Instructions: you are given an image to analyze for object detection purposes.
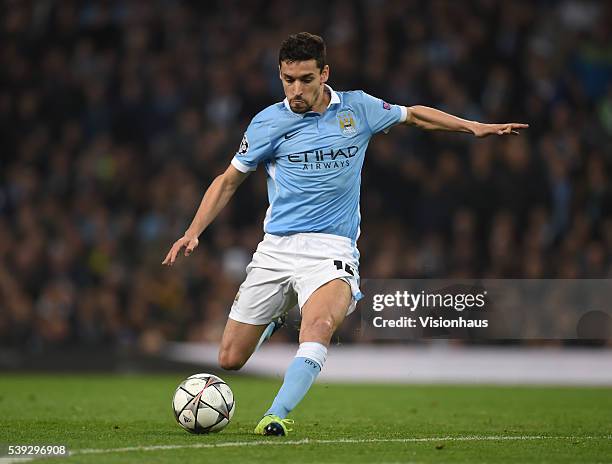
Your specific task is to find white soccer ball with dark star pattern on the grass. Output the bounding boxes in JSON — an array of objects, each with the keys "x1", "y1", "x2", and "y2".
[{"x1": 172, "y1": 374, "x2": 236, "y2": 433}]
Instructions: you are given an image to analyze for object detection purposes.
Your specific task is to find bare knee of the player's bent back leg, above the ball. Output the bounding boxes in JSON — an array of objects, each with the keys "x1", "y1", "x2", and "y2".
[{"x1": 219, "y1": 319, "x2": 267, "y2": 370}]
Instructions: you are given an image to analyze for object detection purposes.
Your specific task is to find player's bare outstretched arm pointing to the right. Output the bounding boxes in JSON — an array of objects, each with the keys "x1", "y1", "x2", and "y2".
[{"x1": 404, "y1": 105, "x2": 529, "y2": 137}]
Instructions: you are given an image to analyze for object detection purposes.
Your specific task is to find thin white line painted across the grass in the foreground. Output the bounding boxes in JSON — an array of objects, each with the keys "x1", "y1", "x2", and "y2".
[{"x1": 70, "y1": 435, "x2": 612, "y2": 456}]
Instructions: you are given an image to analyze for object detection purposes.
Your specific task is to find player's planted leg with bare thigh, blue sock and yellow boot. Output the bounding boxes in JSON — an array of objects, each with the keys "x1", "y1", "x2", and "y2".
[{"x1": 255, "y1": 279, "x2": 352, "y2": 435}]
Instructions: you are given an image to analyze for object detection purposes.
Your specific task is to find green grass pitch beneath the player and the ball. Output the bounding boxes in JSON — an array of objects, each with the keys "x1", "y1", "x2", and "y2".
[{"x1": 0, "y1": 374, "x2": 612, "y2": 463}]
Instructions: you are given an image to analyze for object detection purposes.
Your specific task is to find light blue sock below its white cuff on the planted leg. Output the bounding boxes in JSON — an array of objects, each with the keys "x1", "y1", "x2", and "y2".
[{"x1": 265, "y1": 358, "x2": 321, "y2": 419}]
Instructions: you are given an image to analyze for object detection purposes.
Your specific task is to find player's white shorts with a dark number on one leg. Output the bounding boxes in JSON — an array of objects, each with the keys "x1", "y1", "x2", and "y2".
[{"x1": 229, "y1": 233, "x2": 362, "y2": 325}]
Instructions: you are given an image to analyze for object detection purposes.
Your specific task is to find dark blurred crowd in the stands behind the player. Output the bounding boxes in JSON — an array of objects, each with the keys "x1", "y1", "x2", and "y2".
[{"x1": 0, "y1": 0, "x2": 612, "y2": 352}]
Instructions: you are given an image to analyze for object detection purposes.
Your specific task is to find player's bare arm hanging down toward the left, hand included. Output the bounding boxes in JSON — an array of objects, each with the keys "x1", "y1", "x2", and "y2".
[{"x1": 162, "y1": 164, "x2": 250, "y2": 266}]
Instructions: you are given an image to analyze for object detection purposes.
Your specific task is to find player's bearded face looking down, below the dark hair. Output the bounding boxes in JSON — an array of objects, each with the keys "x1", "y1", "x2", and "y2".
[{"x1": 279, "y1": 60, "x2": 329, "y2": 113}]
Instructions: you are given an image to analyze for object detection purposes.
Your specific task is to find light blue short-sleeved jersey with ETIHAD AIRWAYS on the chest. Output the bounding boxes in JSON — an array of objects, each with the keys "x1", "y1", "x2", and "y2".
[{"x1": 232, "y1": 87, "x2": 406, "y2": 242}]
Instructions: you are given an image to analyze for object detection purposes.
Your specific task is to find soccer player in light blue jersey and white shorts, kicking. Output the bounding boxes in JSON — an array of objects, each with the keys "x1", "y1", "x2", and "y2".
[{"x1": 163, "y1": 32, "x2": 528, "y2": 435}]
